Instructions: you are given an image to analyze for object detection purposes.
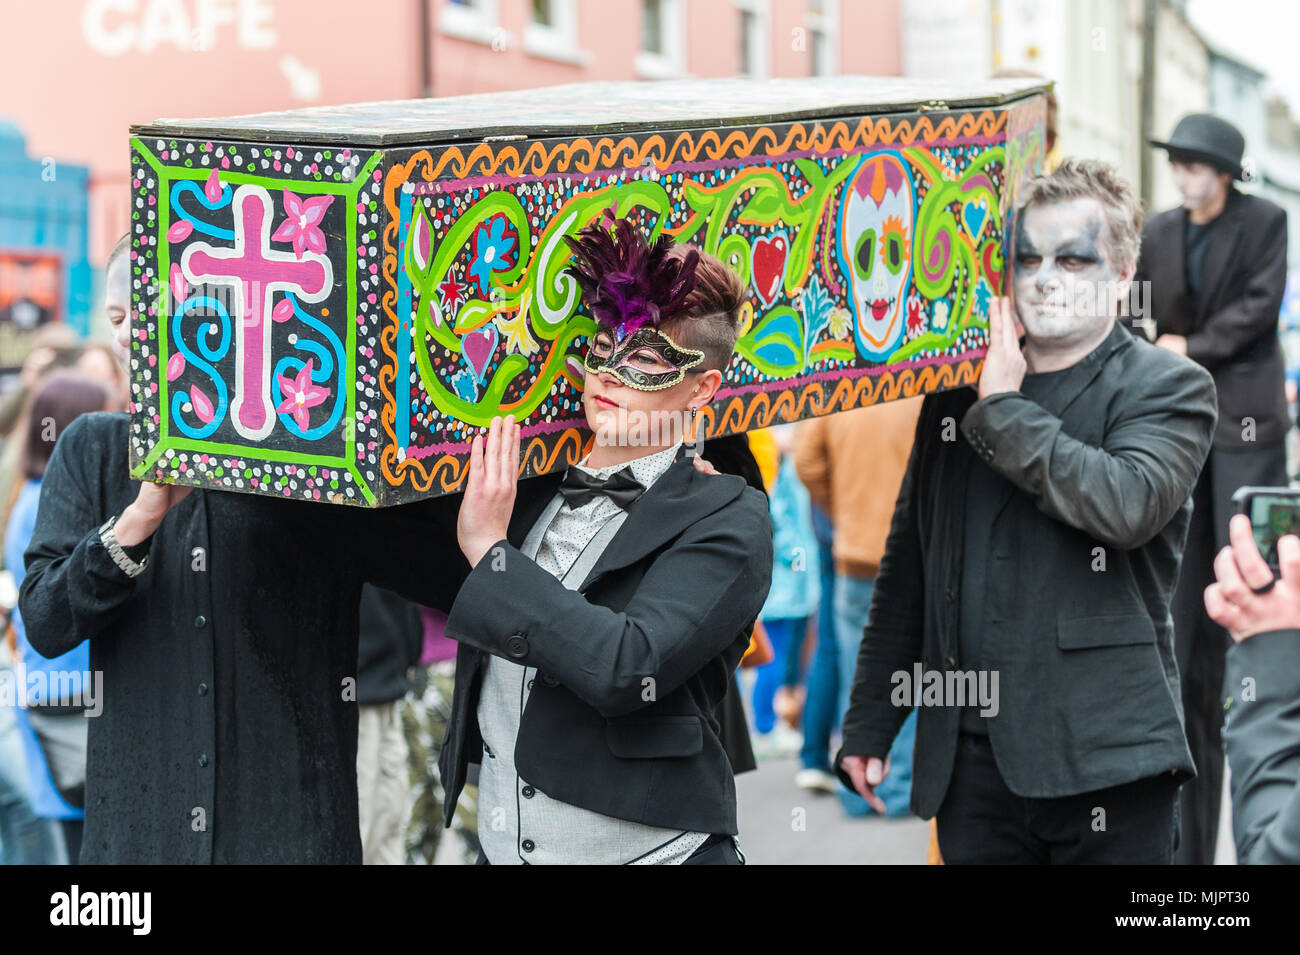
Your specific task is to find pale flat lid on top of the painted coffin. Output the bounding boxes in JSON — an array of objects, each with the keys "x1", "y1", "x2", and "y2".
[{"x1": 131, "y1": 75, "x2": 1052, "y2": 147}]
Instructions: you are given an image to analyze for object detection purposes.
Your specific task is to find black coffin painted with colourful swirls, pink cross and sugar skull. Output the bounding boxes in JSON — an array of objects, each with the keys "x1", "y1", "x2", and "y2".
[{"x1": 130, "y1": 77, "x2": 1045, "y2": 507}]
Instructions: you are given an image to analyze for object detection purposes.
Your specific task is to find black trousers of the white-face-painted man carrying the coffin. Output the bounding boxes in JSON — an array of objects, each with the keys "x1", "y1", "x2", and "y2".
[{"x1": 936, "y1": 734, "x2": 1178, "y2": 865}]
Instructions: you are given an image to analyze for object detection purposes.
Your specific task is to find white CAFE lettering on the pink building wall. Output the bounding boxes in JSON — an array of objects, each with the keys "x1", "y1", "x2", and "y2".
[{"x1": 82, "y1": 0, "x2": 280, "y2": 56}]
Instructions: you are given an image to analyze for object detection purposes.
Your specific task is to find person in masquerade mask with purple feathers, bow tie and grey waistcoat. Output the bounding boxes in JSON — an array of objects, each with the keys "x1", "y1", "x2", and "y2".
[{"x1": 439, "y1": 213, "x2": 772, "y2": 864}]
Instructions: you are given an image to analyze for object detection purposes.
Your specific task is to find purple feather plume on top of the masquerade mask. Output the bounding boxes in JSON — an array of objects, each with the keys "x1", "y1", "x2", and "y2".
[{"x1": 564, "y1": 212, "x2": 699, "y2": 334}]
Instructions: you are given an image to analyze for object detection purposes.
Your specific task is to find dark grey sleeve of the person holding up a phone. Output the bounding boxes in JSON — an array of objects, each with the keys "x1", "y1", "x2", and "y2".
[{"x1": 1223, "y1": 630, "x2": 1300, "y2": 865}]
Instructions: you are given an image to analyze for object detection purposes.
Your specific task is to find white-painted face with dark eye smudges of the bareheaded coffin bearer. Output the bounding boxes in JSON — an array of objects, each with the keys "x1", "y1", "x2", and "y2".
[{"x1": 1013, "y1": 199, "x2": 1131, "y2": 350}]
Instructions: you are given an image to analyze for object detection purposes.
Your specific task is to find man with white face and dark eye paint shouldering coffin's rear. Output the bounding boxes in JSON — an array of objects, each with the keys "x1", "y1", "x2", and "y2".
[{"x1": 836, "y1": 160, "x2": 1216, "y2": 863}]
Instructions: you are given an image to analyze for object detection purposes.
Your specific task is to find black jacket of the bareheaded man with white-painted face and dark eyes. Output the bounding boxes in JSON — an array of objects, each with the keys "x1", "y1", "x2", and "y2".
[{"x1": 836, "y1": 324, "x2": 1214, "y2": 817}]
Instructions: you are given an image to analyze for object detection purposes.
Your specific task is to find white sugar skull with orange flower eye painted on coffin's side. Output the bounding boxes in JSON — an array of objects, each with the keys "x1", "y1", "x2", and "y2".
[{"x1": 840, "y1": 153, "x2": 914, "y2": 359}]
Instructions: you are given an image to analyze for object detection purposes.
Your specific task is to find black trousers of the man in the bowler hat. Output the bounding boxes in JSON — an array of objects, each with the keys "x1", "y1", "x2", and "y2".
[{"x1": 1171, "y1": 444, "x2": 1287, "y2": 865}]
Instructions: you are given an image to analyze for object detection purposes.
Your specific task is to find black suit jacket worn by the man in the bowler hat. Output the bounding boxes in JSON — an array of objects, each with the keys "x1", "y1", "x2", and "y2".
[{"x1": 1135, "y1": 190, "x2": 1291, "y2": 451}]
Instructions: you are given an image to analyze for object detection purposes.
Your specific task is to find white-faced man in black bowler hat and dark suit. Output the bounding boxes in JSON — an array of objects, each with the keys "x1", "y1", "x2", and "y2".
[{"x1": 1134, "y1": 113, "x2": 1291, "y2": 864}]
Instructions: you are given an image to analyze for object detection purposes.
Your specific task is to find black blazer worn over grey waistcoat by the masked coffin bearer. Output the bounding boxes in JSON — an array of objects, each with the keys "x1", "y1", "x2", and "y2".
[{"x1": 438, "y1": 456, "x2": 772, "y2": 834}]
